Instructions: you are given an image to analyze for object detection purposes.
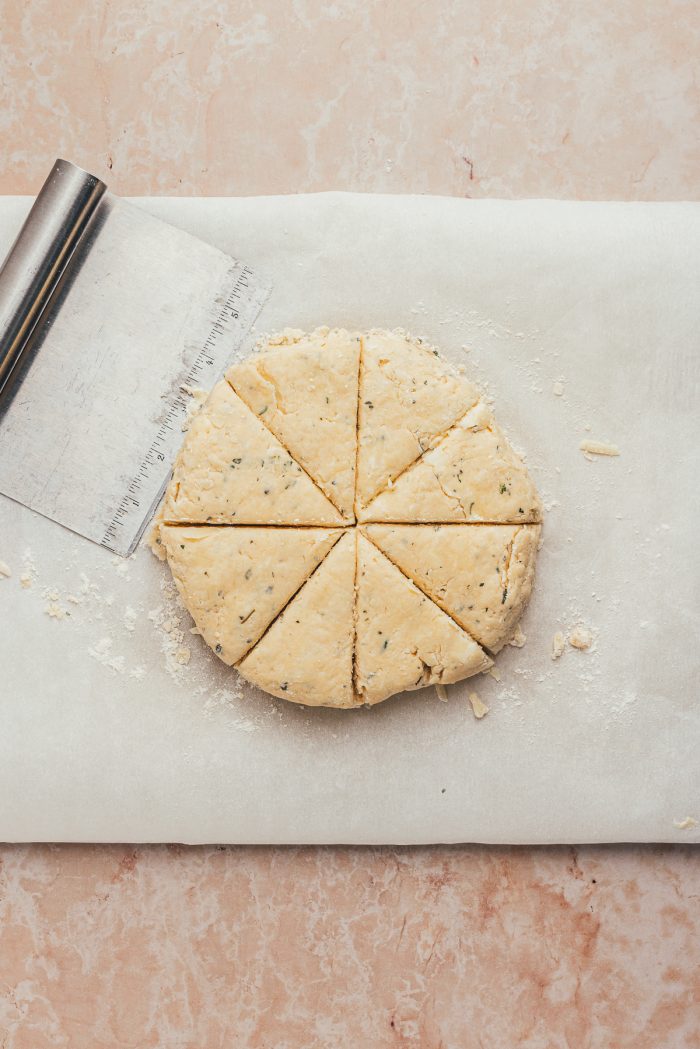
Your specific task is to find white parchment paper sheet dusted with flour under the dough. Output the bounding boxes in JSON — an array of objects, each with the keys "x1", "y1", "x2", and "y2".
[{"x1": 0, "y1": 194, "x2": 700, "y2": 842}]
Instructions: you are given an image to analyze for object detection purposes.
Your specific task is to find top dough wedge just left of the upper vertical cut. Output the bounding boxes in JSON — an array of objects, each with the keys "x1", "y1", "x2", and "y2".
[{"x1": 226, "y1": 328, "x2": 360, "y2": 521}]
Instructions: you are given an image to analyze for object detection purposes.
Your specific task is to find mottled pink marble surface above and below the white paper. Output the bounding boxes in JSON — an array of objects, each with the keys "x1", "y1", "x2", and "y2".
[{"x1": 0, "y1": 0, "x2": 700, "y2": 1049}]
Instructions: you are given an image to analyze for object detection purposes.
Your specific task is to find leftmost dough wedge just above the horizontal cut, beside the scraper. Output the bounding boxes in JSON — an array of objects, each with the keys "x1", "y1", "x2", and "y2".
[{"x1": 163, "y1": 382, "x2": 343, "y2": 525}]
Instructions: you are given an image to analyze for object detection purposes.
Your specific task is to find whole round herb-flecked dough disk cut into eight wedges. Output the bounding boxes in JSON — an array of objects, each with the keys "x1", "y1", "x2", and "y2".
[{"x1": 157, "y1": 328, "x2": 542, "y2": 708}]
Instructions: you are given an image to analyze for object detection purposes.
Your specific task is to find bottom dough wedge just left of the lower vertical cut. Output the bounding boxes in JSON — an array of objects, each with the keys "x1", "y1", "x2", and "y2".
[{"x1": 238, "y1": 534, "x2": 356, "y2": 707}]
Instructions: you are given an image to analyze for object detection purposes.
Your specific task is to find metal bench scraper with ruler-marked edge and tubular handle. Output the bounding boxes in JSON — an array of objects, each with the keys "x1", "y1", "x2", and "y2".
[{"x1": 0, "y1": 160, "x2": 270, "y2": 556}]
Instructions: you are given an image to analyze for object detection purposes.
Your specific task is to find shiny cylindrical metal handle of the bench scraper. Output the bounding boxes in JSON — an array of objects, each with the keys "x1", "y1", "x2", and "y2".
[{"x1": 0, "y1": 160, "x2": 107, "y2": 398}]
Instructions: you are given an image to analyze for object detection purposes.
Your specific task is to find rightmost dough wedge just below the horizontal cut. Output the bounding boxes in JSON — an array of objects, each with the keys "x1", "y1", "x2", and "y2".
[{"x1": 365, "y1": 525, "x2": 540, "y2": 652}]
